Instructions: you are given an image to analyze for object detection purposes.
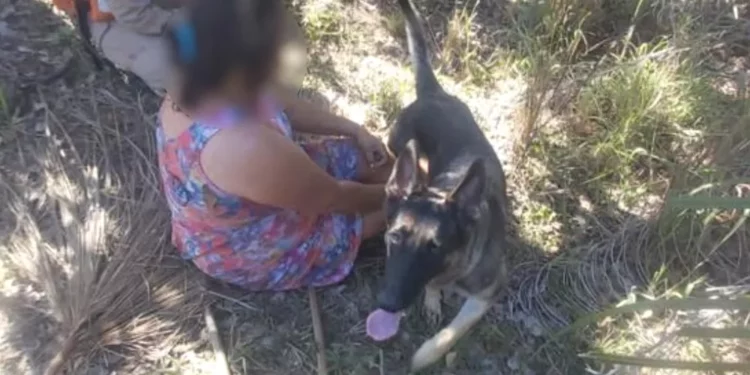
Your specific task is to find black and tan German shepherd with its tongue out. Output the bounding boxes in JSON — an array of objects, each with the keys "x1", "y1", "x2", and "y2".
[{"x1": 377, "y1": 0, "x2": 507, "y2": 371}]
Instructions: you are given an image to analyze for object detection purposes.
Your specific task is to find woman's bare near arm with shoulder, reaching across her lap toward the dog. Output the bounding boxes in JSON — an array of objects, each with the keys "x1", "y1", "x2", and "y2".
[{"x1": 201, "y1": 126, "x2": 385, "y2": 215}]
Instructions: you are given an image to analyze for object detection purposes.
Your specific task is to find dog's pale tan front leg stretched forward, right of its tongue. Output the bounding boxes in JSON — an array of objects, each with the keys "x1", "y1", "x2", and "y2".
[{"x1": 411, "y1": 297, "x2": 491, "y2": 372}]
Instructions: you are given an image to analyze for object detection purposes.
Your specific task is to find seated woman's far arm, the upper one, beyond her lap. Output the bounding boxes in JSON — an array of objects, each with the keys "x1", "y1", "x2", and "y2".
[{"x1": 278, "y1": 90, "x2": 367, "y2": 138}]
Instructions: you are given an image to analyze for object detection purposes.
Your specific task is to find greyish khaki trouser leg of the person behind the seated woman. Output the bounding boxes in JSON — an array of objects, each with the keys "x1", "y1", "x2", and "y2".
[{"x1": 91, "y1": 21, "x2": 171, "y2": 96}]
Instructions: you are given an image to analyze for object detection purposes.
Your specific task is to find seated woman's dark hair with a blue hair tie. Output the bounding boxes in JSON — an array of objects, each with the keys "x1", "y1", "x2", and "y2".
[{"x1": 166, "y1": 0, "x2": 284, "y2": 108}]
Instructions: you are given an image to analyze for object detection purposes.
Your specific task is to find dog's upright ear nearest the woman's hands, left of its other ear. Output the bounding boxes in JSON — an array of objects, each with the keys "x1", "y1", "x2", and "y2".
[{"x1": 385, "y1": 138, "x2": 424, "y2": 197}]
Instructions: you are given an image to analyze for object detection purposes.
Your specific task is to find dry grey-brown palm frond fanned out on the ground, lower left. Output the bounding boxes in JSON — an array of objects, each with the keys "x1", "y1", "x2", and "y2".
[{"x1": 4, "y1": 150, "x2": 202, "y2": 374}]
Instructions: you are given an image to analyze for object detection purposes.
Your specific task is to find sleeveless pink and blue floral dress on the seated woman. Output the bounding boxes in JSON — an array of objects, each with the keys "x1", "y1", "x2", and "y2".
[{"x1": 157, "y1": 98, "x2": 362, "y2": 291}]
